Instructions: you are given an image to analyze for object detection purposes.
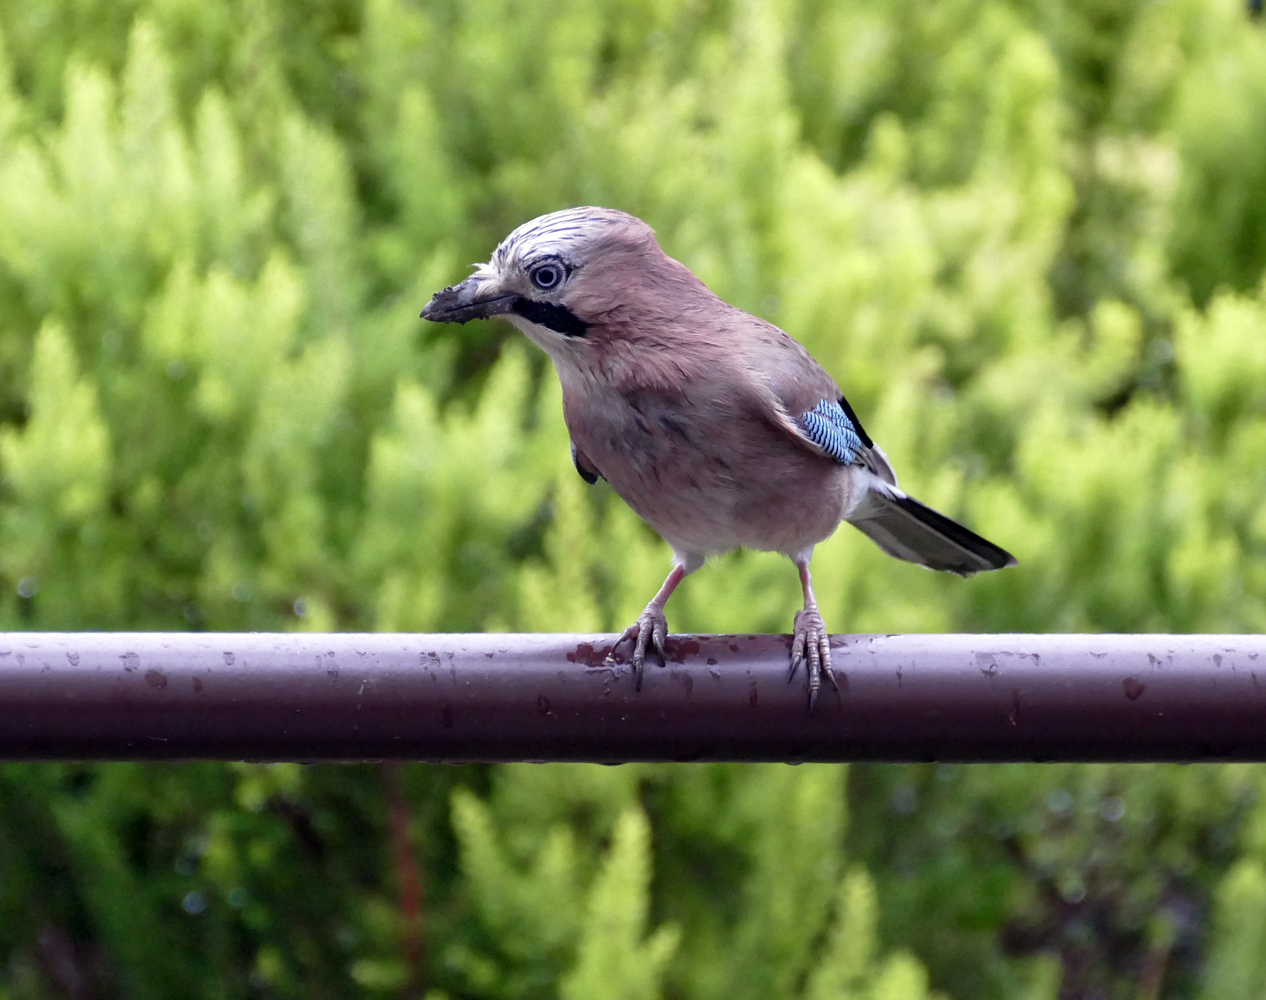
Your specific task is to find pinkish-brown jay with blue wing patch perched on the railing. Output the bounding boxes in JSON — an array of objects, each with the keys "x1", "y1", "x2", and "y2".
[{"x1": 422, "y1": 206, "x2": 1017, "y2": 713}]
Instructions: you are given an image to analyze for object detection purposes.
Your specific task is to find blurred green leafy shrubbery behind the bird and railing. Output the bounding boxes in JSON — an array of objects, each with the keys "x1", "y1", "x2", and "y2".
[{"x1": 0, "y1": 0, "x2": 1266, "y2": 1000}]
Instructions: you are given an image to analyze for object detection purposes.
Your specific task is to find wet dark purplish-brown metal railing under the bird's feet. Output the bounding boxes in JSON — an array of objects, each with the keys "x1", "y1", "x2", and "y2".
[{"x1": 0, "y1": 633, "x2": 1266, "y2": 762}]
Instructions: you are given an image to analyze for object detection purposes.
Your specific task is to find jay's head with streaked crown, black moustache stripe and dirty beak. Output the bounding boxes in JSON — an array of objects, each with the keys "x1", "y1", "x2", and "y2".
[{"x1": 422, "y1": 208, "x2": 694, "y2": 356}]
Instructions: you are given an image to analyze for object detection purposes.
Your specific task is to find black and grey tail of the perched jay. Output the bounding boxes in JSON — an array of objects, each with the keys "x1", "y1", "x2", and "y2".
[{"x1": 848, "y1": 482, "x2": 1015, "y2": 576}]
